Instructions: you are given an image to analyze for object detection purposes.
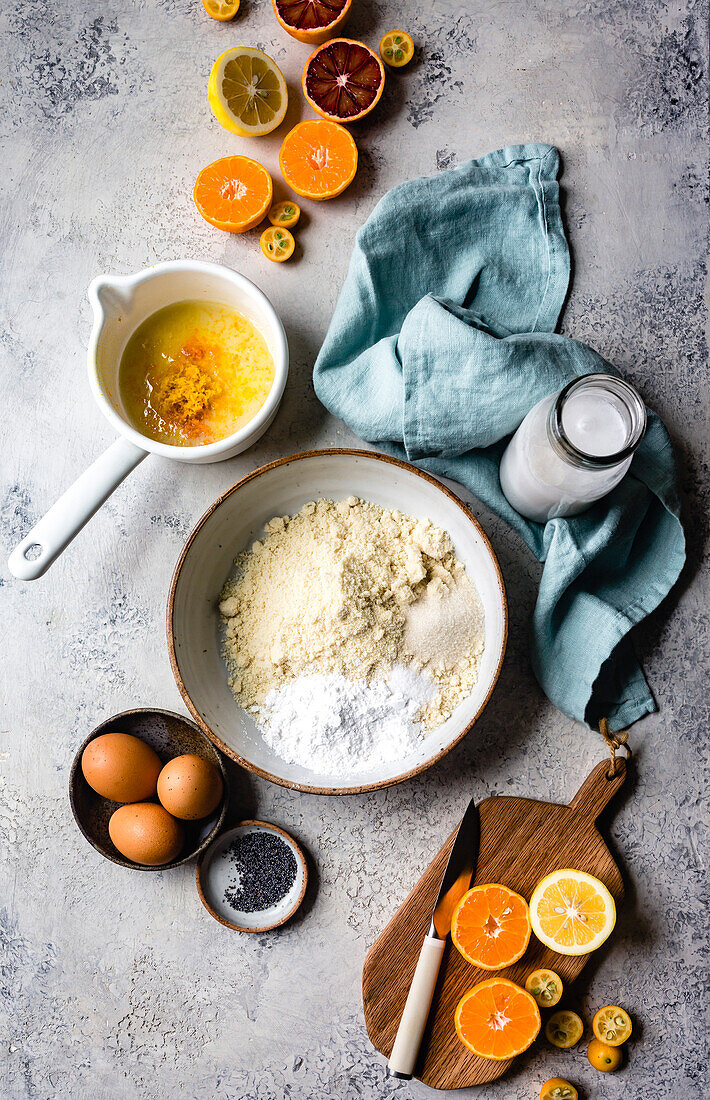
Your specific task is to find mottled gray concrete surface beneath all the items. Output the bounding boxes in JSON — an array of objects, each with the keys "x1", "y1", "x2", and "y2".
[{"x1": 0, "y1": 0, "x2": 709, "y2": 1100}]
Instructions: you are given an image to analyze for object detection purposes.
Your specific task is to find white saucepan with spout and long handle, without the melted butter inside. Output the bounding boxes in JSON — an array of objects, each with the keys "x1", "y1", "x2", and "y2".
[{"x1": 8, "y1": 260, "x2": 288, "y2": 581}]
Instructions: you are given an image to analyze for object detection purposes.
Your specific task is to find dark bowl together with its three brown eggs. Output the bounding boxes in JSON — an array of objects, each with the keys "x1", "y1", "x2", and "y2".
[{"x1": 69, "y1": 708, "x2": 227, "y2": 871}]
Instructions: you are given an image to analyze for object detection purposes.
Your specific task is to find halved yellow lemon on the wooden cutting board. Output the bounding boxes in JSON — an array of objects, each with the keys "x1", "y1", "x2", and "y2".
[{"x1": 531, "y1": 868, "x2": 616, "y2": 955}]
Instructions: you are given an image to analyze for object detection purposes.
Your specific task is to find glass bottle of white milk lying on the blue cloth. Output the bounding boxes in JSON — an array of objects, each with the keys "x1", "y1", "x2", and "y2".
[{"x1": 500, "y1": 374, "x2": 646, "y2": 524}]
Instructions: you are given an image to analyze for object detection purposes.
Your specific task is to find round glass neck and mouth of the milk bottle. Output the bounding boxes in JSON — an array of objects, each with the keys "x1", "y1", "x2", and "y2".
[{"x1": 547, "y1": 374, "x2": 646, "y2": 470}]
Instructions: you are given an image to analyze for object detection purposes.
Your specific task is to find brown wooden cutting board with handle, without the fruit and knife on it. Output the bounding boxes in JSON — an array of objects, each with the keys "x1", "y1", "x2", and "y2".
[{"x1": 362, "y1": 757, "x2": 626, "y2": 1089}]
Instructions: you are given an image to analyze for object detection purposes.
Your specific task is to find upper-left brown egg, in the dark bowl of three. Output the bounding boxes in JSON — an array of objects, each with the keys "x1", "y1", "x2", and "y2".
[{"x1": 81, "y1": 734, "x2": 163, "y2": 802}]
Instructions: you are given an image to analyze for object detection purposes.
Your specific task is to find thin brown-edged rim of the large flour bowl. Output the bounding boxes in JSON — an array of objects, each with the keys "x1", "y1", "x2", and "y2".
[{"x1": 165, "y1": 447, "x2": 509, "y2": 794}]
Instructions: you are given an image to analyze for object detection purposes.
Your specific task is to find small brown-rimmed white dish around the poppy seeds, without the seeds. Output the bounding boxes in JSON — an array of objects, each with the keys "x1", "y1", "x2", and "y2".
[{"x1": 195, "y1": 822, "x2": 308, "y2": 932}]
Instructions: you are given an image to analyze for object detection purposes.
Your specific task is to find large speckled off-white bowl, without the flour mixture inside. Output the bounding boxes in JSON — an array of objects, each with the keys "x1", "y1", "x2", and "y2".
[{"x1": 167, "y1": 450, "x2": 507, "y2": 794}]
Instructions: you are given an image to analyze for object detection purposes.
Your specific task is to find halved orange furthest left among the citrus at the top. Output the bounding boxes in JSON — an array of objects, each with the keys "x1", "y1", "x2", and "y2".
[{"x1": 193, "y1": 156, "x2": 274, "y2": 233}]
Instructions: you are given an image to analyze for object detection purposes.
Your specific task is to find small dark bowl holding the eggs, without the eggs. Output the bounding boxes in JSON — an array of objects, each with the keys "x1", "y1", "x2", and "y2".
[{"x1": 69, "y1": 707, "x2": 228, "y2": 871}]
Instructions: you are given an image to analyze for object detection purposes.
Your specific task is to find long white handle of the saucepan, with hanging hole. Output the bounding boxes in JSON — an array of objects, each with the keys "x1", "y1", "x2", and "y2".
[{"x1": 8, "y1": 439, "x2": 148, "y2": 581}]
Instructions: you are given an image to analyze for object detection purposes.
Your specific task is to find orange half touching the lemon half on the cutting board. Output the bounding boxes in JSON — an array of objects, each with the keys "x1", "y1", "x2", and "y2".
[{"x1": 451, "y1": 882, "x2": 531, "y2": 970}]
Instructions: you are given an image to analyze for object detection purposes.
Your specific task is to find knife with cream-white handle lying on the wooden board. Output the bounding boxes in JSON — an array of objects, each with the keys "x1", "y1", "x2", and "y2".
[{"x1": 387, "y1": 799, "x2": 480, "y2": 1081}]
